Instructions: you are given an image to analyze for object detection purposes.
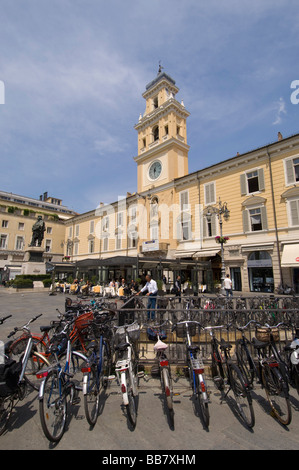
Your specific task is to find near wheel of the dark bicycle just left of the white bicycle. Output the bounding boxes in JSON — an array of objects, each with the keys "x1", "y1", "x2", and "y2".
[{"x1": 83, "y1": 364, "x2": 100, "y2": 426}]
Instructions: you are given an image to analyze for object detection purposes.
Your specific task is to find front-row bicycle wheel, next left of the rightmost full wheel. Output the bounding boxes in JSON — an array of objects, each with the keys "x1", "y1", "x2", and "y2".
[{"x1": 229, "y1": 364, "x2": 255, "y2": 428}]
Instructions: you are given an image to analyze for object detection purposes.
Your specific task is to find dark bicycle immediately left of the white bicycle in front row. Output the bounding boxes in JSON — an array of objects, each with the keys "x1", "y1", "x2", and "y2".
[{"x1": 82, "y1": 314, "x2": 114, "y2": 426}]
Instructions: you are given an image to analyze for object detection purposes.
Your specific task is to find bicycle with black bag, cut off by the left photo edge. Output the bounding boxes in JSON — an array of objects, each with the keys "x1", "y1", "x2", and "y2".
[{"x1": 0, "y1": 315, "x2": 49, "y2": 436}]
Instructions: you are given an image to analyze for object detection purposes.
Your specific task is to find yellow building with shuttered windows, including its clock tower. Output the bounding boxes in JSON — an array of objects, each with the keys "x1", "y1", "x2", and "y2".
[{"x1": 64, "y1": 71, "x2": 299, "y2": 292}]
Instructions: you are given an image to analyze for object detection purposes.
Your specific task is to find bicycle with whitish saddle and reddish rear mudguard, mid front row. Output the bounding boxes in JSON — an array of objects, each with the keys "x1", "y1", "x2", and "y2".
[{"x1": 144, "y1": 320, "x2": 174, "y2": 428}]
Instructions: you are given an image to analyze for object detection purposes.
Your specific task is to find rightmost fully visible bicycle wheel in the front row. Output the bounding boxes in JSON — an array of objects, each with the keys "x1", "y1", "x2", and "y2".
[{"x1": 262, "y1": 364, "x2": 292, "y2": 426}]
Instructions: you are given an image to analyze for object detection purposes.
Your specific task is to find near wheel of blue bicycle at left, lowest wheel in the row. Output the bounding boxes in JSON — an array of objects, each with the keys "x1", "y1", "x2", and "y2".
[{"x1": 39, "y1": 371, "x2": 67, "y2": 442}]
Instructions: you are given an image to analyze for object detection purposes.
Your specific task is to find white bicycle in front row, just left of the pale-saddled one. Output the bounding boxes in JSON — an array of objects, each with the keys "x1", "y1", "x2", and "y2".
[{"x1": 114, "y1": 322, "x2": 140, "y2": 428}]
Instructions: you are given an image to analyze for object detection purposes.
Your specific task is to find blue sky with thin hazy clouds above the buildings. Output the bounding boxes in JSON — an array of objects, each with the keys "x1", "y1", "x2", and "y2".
[{"x1": 0, "y1": 0, "x2": 299, "y2": 212}]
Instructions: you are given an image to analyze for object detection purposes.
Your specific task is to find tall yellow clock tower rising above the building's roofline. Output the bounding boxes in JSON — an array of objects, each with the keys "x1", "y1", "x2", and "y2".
[{"x1": 134, "y1": 67, "x2": 190, "y2": 193}]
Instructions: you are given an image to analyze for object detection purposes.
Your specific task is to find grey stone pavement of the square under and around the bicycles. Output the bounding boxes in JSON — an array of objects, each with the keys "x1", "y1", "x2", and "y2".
[{"x1": 0, "y1": 290, "x2": 299, "y2": 454}]
